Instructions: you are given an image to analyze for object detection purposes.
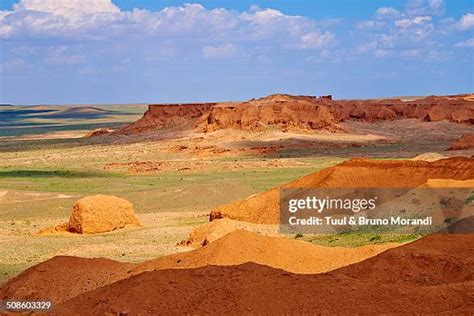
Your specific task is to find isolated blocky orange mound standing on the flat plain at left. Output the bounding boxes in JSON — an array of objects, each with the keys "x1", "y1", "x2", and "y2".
[{"x1": 38, "y1": 194, "x2": 140, "y2": 235}]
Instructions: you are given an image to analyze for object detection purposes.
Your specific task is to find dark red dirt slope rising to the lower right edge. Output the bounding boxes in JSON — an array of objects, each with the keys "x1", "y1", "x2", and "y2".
[{"x1": 338, "y1": 232, "x2": 474, "y2": 286}]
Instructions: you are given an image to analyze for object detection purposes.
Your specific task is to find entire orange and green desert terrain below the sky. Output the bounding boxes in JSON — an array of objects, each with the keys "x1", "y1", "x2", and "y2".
[{"x1": 0, "y1": 94, "x2": 474, "y2": 315}]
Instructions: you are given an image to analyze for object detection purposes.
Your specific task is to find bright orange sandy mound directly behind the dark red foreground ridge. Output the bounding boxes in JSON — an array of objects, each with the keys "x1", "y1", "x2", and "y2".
[{"x1": 133, "y1": 230, "x2": 399, "y2": 273}]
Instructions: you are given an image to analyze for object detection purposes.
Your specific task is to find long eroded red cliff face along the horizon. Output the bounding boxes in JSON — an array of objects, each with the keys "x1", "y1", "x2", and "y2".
[{"x1": 119, "y1": 94, "x2": 474, "y2": 134}]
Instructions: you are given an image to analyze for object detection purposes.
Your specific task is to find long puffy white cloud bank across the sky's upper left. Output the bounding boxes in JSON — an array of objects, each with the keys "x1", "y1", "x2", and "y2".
[{"x1": 0, "y1": 0, "x2": 334, "y2": 48}]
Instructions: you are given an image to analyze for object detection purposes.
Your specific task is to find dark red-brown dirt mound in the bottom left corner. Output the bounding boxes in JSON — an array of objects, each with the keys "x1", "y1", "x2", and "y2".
[{"x1": 0, "y1": 257, "x2": 134, "y2": 304}]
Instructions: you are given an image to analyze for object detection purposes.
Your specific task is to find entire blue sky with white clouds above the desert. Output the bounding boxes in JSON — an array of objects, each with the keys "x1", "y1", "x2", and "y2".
[{"x1": 0, "y1": 0, "x2": 474, "y2": 104}]
